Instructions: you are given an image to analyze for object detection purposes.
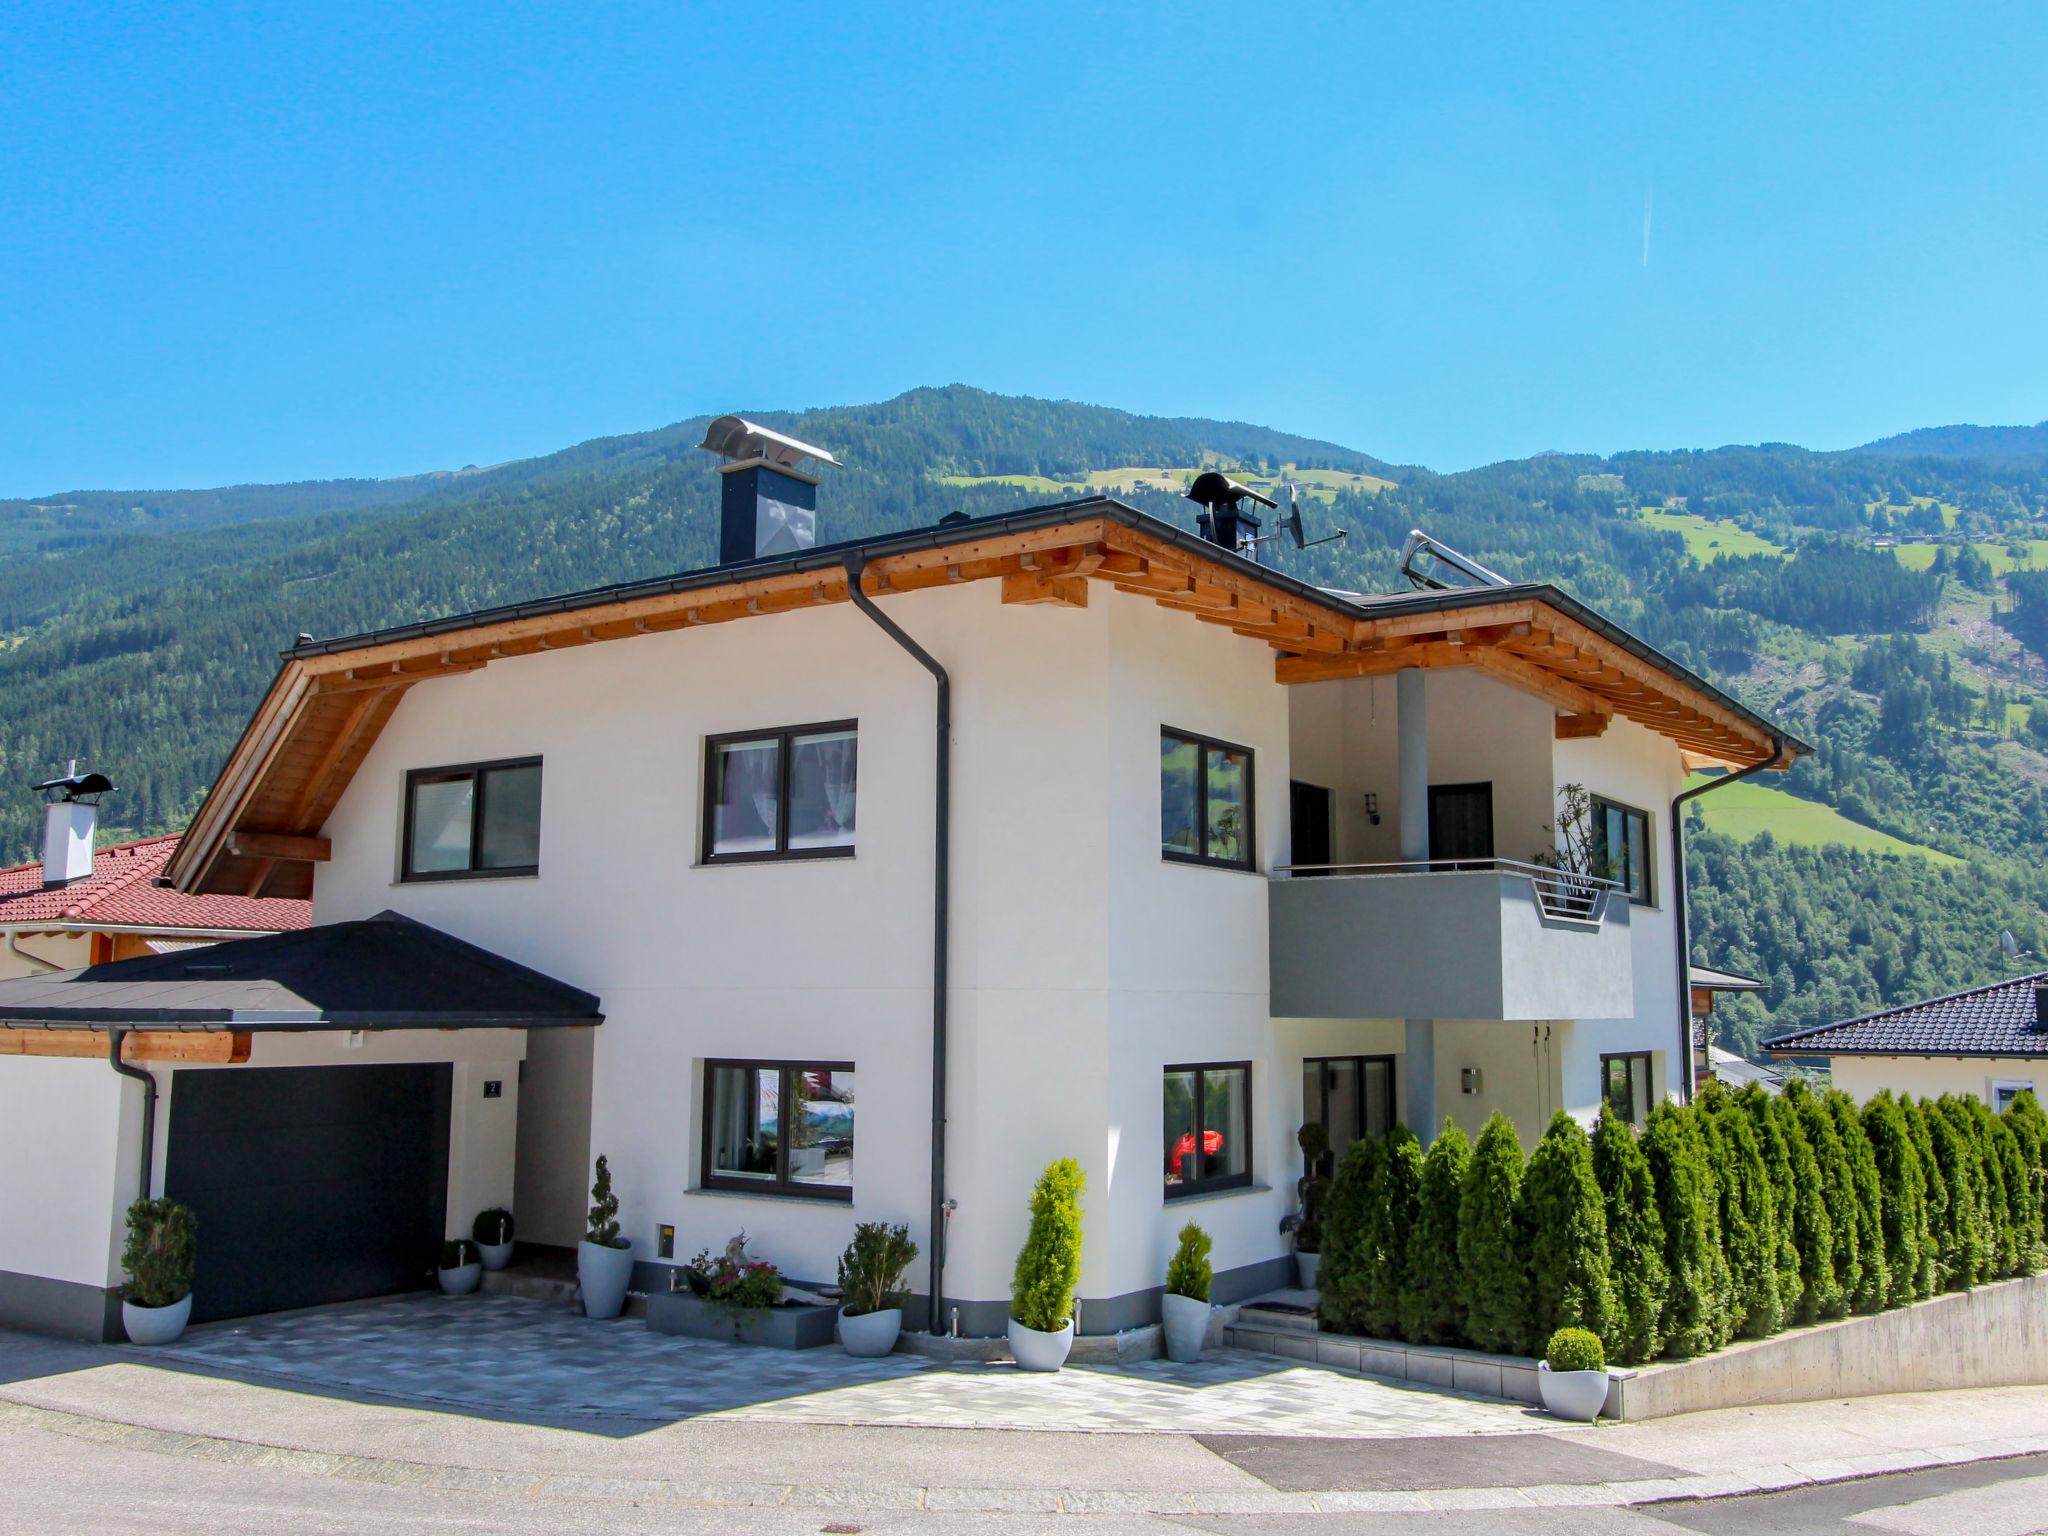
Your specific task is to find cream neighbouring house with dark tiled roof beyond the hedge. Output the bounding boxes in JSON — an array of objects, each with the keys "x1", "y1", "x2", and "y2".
[{"x1": 1763, "y1": 971, "x2": 2048, "y2": 1110}]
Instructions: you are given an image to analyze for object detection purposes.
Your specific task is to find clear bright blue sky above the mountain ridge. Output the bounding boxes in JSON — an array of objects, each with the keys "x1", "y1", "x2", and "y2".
[{"x1": 0, "y1": 2, "x2": 2048, "y2": 494}]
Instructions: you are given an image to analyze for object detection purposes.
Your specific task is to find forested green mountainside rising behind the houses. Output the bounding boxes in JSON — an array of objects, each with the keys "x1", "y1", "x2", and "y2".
[{"x1": 0, "y1": 387, "x2": 2048, "y2": 1049}]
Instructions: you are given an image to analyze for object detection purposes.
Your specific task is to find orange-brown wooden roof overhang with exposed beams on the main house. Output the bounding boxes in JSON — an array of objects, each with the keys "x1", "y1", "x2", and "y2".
[{"x1": 168, "y1": 498, "x2": 1806, "y2": 897}]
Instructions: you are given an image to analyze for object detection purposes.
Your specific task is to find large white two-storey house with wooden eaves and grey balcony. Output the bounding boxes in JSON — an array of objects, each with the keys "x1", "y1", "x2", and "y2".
[{"x1": 0, "y1": 420, "x2": 1806, "y2": 1333}]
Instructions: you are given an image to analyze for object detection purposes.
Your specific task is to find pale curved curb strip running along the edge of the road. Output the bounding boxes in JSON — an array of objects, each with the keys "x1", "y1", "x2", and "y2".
[{"x1": 0, "y1": 1399, "x2": 2048, "y2": 1516}]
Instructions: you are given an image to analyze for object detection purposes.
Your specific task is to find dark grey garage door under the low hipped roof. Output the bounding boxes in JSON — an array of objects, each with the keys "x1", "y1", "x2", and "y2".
[{"x1": 164, "y1": 1065, "x2": 451, "y2": 1323}]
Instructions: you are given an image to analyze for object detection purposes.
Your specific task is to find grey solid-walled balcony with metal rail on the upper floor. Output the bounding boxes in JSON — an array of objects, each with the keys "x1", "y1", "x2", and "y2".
[{"x1": 1268, "y1": 858, "x2": 1636, "y2": 1020}]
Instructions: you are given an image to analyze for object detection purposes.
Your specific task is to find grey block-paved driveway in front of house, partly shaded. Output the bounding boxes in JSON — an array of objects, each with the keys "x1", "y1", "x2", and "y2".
[{"x1": 133, "y1": 1294, "x2": 1550, "y2": 1438}]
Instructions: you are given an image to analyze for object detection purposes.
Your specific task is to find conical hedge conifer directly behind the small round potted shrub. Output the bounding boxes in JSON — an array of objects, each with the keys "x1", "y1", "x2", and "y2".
[{"x1": 1522, "y1": 1110, "x2": 1614, "y2": 1339}]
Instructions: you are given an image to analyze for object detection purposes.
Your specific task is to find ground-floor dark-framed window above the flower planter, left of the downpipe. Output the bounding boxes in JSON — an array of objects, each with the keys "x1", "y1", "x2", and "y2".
[{"x1": 705, "y1": 1061, "x2": 854, "y2": 1200}]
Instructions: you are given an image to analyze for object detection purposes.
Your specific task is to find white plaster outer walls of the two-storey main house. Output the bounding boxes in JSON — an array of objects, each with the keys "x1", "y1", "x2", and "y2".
[{"x1": 313, "y1": 582, "x2": 1683, "y2": 1331}]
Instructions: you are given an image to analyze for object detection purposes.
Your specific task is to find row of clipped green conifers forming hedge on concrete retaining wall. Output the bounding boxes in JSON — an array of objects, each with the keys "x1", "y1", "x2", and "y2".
[{"x1": 1321, "y1": 1081, "x2": 2048, "y2": 1364}]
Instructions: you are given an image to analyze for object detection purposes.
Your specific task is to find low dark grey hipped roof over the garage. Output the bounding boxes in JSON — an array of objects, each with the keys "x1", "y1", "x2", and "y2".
[{"x1": 0, "y1": 911, "x2": 604, "y2": 1030}]
